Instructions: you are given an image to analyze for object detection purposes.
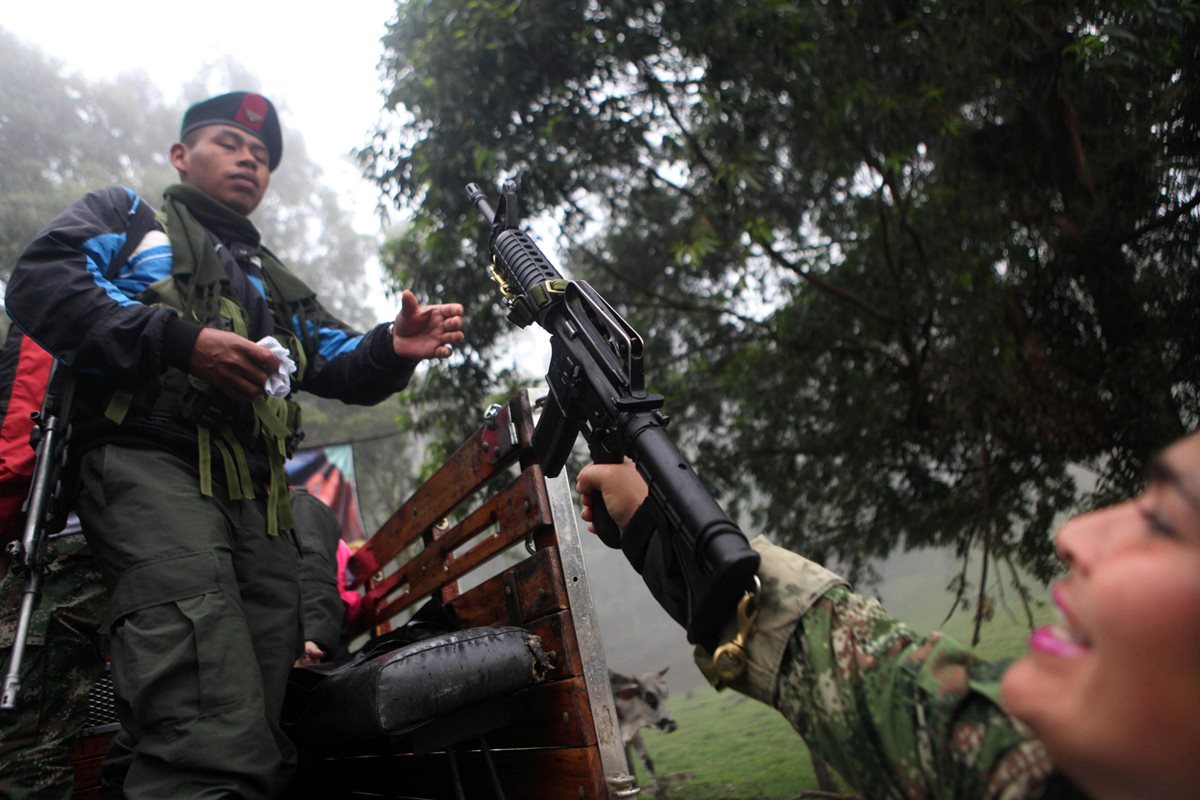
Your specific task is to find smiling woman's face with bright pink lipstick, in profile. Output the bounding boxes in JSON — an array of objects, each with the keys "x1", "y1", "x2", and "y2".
[{"x1": 1002, "y1": 435, "x2": 1200, "y2": 798}]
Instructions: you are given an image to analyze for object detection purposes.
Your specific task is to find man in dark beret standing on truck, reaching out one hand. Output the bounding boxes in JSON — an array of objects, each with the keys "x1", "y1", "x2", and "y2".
[{"x1": 6, "y1": 91, "x2": 462, "y2": 799}]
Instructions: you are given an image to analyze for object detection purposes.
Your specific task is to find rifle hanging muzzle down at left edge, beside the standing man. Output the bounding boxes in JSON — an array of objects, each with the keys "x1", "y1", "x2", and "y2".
[{"x1": 0, "y1": 361, "x2": 74, "y2": 711}]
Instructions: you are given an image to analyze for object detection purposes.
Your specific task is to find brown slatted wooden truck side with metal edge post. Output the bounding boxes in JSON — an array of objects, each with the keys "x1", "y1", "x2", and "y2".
[{"x1": 69, "y1": 392, "x2": 638, "y2": 800}]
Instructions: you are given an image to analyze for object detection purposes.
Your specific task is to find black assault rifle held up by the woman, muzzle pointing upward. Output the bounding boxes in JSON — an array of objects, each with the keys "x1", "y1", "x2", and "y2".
[{"x1": 467, "y1": 184, "x2": 758, "y2": 651}]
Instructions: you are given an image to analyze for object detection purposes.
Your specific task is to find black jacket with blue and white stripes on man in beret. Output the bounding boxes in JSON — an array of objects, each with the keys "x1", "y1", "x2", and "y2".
[{"x1": 5, "y1": 187, "x2": 416, "y2": 472}]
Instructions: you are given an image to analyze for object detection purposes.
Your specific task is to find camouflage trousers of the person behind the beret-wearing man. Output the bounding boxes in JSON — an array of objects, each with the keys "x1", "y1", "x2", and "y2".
[{"x1": 0, "y1": 535, "x2": 108, "y2": 800}]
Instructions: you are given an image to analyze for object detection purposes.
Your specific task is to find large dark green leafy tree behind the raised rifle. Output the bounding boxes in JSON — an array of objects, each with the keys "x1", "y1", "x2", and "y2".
[{"x1": 364, "y1": 0, "x2": 1200, "y2": 633}]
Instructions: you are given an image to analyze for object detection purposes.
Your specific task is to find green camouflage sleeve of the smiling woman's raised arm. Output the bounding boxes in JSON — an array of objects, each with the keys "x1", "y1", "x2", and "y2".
[{"x1": 697, "y1": 540, "x2": 1051, "y2": 800}]
